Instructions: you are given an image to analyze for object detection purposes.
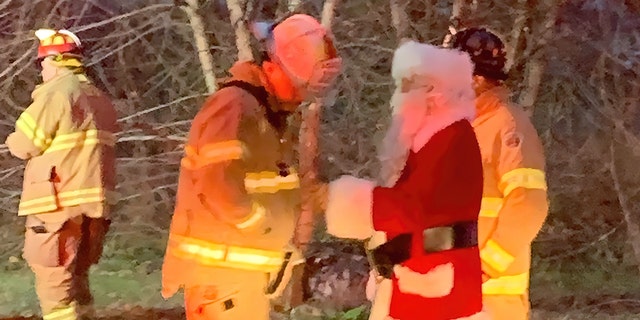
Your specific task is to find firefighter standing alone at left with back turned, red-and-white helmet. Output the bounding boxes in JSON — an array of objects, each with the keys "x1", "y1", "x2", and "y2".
[{"x1": 6, "y1": 29, "x2": 117, "y2": 320}]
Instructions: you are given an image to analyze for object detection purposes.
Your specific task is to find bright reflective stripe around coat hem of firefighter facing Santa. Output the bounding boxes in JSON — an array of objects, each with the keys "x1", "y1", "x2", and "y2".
[{"x1": 169, "y1": 234, "x2": 284, "y2": 272}]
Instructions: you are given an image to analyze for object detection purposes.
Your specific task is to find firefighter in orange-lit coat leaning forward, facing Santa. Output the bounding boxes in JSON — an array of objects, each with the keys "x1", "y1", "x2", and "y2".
[{"x1": 162, "y1": 14, "x2": 341, "y2": 320}]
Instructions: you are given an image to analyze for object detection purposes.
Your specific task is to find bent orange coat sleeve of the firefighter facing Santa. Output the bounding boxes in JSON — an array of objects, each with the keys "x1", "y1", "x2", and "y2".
[{"x1": 181, "y1": 97, "x2": 266, "y2": 231}]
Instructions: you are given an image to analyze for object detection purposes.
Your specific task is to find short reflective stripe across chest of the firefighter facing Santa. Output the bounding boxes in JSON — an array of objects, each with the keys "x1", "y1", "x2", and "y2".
[{"x1": 244, "y1": 171, "x2": 300, "y2": 193}]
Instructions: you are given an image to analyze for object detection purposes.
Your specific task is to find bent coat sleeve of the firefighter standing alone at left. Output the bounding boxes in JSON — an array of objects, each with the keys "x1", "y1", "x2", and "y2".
[{"x1": 5, "y1": 92, "x2": 67, "y2": 160}]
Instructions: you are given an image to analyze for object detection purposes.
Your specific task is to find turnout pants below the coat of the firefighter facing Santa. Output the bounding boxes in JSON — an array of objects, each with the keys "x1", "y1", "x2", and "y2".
[{"x1": 184, "y1": 268, "x2": 270, "y2": 320}]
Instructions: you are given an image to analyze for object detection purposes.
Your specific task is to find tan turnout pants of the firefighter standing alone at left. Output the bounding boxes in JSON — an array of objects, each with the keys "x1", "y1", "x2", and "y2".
[{"x1": 23, "y1": 215, "x2": 110, "y2": 320}]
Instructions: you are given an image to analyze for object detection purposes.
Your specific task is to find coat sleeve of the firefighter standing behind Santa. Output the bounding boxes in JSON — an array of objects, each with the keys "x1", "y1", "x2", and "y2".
[{"x1": 480, "y1": 128, "x2": 548, "y2": 277}]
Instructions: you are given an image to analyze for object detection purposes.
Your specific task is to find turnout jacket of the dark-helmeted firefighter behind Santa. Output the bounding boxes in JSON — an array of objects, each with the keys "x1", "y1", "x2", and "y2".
[{"x1": 473, "y1": 87, "x2": 548, "y2": 295}]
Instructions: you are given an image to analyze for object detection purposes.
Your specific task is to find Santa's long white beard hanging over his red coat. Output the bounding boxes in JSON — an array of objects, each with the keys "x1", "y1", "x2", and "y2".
[{"x1": 378, "y1": 90, "x2": 429, "y2": 187}]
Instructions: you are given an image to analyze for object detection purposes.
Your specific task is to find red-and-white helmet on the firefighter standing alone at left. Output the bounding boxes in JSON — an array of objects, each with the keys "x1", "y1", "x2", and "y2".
[{"x1": 36, "y1": 29, "x2": 82, "y2": 59}]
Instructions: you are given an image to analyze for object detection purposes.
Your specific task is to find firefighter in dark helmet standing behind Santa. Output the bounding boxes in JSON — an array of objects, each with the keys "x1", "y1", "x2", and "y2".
[{"x1": 451, "y1": 28, "x2": 548, "y2": 320}]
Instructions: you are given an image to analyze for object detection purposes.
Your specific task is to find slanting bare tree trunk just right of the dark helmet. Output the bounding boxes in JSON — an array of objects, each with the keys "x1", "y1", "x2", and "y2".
[{"x1": 518, "y1": 0, "x2": 564, "y2": 116}]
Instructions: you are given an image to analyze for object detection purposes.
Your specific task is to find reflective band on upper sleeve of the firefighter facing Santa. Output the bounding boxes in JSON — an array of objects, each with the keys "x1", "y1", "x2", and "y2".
[{"x1": 180, "y1": 140, "x2": 243, "y2": 170}]
